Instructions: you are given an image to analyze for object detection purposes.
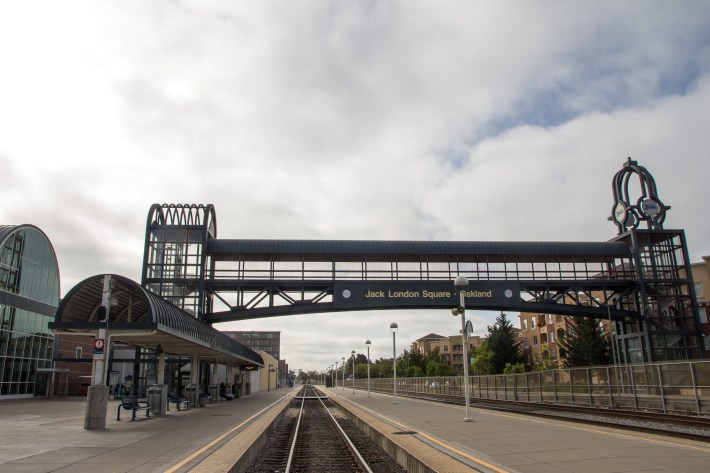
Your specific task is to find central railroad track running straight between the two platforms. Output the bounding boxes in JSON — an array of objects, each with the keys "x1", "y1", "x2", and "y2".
[{"x1": 247, "y1": 386, "x2": 404, "y2": 473}]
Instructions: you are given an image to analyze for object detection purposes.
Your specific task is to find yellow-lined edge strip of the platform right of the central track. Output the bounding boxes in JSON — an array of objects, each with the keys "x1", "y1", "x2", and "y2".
[{"x1": 332, "y1": 390, "x2": 508, "y2": 473}]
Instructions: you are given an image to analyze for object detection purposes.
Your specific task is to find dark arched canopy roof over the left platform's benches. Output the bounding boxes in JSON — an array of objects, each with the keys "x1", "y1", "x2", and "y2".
[{"x1": 49, "y1": 275, "x2": 264, "y2": 367}]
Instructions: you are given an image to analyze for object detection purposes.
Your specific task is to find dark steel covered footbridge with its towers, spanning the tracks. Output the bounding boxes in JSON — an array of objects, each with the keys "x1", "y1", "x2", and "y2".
[{"x1": 142, "y1": 204, "x2": 702, "y2": 361}]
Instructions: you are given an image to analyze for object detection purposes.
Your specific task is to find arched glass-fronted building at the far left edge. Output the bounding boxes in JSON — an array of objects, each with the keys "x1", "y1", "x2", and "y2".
[{"x1": 0, "y1": 225, "x2": 59, "y2": 398}]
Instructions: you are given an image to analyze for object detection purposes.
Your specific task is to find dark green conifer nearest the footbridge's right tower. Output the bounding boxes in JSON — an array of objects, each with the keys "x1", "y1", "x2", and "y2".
[{"x1": 557, "y1": 317, "x2": 613, "y2": 368}]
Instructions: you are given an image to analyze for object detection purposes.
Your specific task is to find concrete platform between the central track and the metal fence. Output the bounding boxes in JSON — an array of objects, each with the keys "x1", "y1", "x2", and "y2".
[{"x1": 326, "y1": 387, "x2": 710, "y2": 473}]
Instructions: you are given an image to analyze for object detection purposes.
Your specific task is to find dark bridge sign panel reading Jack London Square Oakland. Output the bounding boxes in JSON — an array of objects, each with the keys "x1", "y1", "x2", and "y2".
[{"x1": 333, "y1": 281, "x2": 520, "y2": 308}]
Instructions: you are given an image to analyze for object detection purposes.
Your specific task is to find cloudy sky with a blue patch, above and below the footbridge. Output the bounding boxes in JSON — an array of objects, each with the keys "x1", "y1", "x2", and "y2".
[{"x1": 0, "y1": 0, "x2": 710, "y2": 370}]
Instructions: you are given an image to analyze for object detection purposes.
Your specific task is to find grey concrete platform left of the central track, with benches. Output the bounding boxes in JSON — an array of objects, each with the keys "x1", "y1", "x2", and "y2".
[{"x1": 0, "y1": 388, "x2": 290, "y2": 473}]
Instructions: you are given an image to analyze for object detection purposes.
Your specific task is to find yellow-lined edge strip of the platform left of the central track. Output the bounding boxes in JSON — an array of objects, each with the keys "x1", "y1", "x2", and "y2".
[{"x1": 165, "y1": 393, "x2": 292, "y2": 473}]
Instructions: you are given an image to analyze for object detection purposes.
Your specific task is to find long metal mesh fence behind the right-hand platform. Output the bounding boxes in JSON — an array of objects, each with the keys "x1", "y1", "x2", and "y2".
[{"x1": 337, "y1": 361, "x2": 710, "y2": 416}]
